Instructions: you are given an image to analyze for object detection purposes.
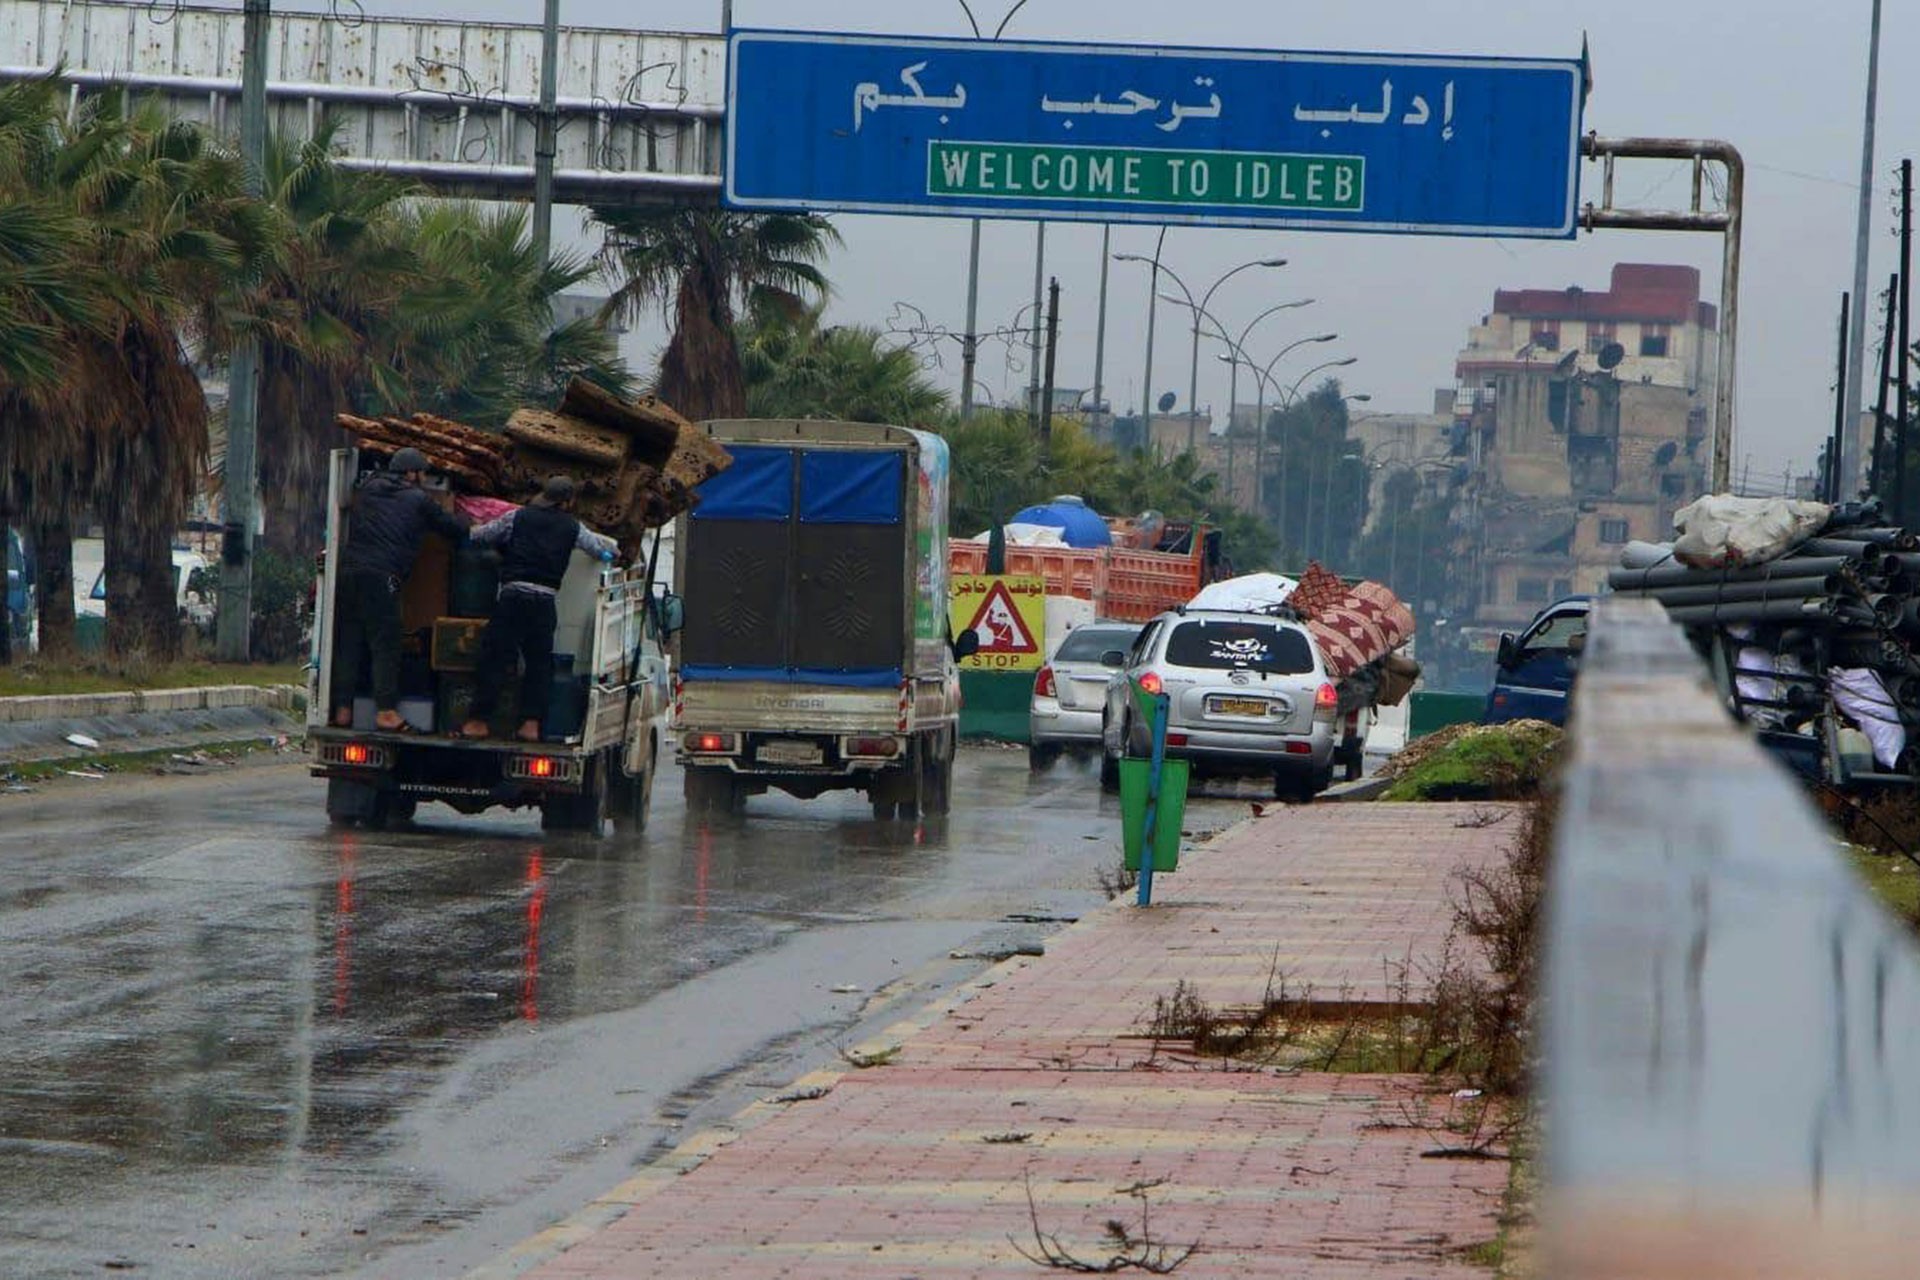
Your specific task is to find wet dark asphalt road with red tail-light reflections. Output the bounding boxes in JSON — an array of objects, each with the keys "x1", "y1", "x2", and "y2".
[{"x1": 0, "y1": 748, "x2": 1246, "y2": 1278}]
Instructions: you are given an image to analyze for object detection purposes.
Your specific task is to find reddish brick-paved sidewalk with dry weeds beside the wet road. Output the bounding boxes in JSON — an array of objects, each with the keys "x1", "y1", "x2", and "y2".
[{"x1": 482, "y1": 804, "x2": 1519, "y2": 1280}]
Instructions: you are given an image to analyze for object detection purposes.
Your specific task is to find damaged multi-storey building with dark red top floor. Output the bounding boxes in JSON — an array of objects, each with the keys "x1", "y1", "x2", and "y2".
[{"x1": 1448, "y1": 263, "x2": 1718, "y2": 652}]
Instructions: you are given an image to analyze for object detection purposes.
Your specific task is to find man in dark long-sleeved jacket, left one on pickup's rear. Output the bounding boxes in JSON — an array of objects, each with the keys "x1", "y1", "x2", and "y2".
[{"x1": 332, "y1": 449, "x2": 468, "y2": 733}]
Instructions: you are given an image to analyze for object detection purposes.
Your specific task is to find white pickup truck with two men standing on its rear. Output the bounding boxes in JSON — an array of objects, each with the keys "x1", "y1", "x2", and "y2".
[{"x1": 307, "y1": 449, "x2": 680, "y2": 833}]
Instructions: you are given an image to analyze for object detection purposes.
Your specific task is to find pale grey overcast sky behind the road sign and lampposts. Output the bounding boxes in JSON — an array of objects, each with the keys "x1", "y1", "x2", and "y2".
[{"x1": 353, "y1": 0, "x2": 1920, "y2": 480}]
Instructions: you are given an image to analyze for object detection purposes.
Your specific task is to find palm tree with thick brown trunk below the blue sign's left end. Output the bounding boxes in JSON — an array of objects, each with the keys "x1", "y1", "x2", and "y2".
[{"x1": 593, "y1": 207, "x2": 841, "y2": 420}]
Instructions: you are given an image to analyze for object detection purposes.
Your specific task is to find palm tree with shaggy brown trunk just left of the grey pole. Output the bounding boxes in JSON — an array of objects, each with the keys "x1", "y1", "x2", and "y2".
[{"x1": 19, "y1": 90, "x2": 269, "y2": 658}]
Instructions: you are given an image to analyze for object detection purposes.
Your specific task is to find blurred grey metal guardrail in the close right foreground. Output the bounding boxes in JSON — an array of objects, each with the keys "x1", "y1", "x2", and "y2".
[{"x1": 1542, "y1": 601, "x2": 1920, "y2": 1280}]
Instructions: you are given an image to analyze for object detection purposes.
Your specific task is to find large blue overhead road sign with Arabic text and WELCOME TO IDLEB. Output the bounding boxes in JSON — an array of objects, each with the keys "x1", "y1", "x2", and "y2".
[{"x1": 724, "y1": 31, "x2": 1586, "y2": 238}]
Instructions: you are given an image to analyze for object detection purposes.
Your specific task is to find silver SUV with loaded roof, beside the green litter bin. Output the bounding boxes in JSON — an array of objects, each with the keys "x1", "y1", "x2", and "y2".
[{"x1": 1100, "y1": 610, "x2": 1340, "y2": 802}]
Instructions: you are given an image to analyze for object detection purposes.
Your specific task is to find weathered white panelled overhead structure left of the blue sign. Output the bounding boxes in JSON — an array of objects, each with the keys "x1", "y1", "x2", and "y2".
[{"x1": 0, "y1": 0, "x2": 726, "y2": 203}]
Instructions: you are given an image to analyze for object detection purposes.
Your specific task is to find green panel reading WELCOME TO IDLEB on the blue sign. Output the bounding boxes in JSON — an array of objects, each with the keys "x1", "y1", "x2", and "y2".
[{"x1": 927, "y1": 142, "x2": 1367, "y2": 213}]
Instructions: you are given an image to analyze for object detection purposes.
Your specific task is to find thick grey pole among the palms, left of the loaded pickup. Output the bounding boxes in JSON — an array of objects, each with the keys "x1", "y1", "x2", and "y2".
[{"x1": 213, "y1": 0, "x2": 273, "y2": 662}]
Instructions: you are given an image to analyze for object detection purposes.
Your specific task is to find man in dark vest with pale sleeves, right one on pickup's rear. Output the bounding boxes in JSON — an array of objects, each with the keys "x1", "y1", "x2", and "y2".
[{"x1": 457, "y1": 476, "x2": 618, "y2": 743}]
